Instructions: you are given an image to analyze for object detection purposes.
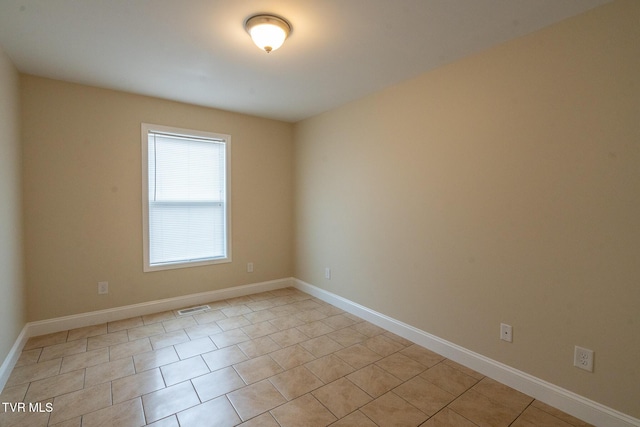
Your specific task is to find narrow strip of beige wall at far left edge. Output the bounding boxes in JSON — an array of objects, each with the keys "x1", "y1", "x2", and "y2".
[{"x1": 0, "y1": 47, "x2": 26, "y2": 363}]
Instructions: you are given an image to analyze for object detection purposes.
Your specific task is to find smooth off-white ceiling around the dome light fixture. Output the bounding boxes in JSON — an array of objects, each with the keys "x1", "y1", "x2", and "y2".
[{"x1": 0, "y1": 0, "x2": 609, "y2": 122}]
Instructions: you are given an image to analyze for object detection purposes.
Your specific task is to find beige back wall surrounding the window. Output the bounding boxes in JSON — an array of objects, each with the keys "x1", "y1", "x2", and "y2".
[{"x1": 22, "y1": 76, "x2": 293, "y2": 321}]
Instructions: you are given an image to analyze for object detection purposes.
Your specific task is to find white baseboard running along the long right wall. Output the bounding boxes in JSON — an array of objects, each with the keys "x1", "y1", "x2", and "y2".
[{"x1": 293, "y1": 279, "x2": 640, "y2": 427}]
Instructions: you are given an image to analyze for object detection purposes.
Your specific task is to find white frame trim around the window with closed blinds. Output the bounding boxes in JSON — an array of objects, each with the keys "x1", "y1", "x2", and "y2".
[{"x1": 141, "y1": 123, "x2": 231, "y2": 272}]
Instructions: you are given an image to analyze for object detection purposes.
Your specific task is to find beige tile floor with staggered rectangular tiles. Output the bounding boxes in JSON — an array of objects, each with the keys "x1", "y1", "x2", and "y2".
[{"x1": 0, "y1": 288, "x2": 587, "y2": 427}]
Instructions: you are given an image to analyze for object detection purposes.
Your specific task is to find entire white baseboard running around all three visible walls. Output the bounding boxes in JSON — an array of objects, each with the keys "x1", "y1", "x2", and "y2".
[{"x1": 0, "y1": 278, "x2": 640, "y2": 427}]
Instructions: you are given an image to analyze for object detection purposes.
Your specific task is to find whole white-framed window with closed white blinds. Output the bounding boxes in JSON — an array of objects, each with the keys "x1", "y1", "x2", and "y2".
[{"x1": 142, "y1": 123, "x2": 231, "y2": 271}]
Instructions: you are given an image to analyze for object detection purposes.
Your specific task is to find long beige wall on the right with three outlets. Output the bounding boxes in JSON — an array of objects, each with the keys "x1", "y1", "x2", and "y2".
[{"x1": 295, "y1": 0, "x2": 640, "y2": 417}]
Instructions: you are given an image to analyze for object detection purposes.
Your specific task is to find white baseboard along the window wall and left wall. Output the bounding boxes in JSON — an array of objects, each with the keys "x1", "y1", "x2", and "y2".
[{"x1": 0, "y1": 278, "x2": 293, "y2": 392}]
